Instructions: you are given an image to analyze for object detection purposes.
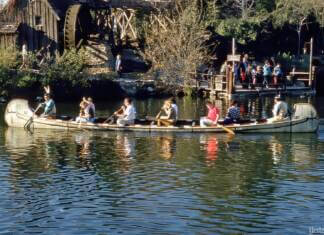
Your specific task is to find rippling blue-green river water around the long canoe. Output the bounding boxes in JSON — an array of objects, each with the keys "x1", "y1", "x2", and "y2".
[{"x1": 0, "y1": 98, "x2": 324, "y2": 234}]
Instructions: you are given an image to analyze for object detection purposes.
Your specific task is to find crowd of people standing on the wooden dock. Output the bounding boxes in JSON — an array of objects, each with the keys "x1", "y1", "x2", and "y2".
[{"x1": 220, "y1": 54, "x2": 286, "y2": 89}]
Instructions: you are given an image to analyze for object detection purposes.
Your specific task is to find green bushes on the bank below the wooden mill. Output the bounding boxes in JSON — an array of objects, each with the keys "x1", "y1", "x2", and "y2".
[{"x1": 0, "y1": 49, "x2": 88, "y2": 95}]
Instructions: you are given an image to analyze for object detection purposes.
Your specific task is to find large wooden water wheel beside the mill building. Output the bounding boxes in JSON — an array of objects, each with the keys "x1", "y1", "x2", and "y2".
[{"x1": 64, "y1": 4, "x2": 92, "y2": 49}]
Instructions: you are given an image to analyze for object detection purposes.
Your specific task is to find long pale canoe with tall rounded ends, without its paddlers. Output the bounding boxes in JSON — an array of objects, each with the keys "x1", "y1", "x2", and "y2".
[{"x1": 5, "y1": 99, "x2": 319, "y2": 133}]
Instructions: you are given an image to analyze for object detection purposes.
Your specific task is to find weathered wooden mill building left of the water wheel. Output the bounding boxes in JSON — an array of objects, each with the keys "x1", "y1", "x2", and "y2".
[{"x1": 0, "y1": 0, "x2": 74, "y2": 54}]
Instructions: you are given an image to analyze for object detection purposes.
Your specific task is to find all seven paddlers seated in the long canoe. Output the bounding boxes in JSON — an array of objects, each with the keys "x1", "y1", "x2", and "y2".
[{"x1": 35, "y1": 87, "x2": 290, "y2": 127}]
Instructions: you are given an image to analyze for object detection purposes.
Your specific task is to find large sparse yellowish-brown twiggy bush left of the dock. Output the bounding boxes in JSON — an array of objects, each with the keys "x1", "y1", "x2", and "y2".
[{"x1": 144, "y1": 2, "x2": 214, "y2": 85}]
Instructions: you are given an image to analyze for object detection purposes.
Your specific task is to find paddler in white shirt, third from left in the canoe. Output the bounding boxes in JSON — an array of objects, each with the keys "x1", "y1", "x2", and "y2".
[{"x1": 114, "y1": 98, "x2": 136, "y2": 126}]
